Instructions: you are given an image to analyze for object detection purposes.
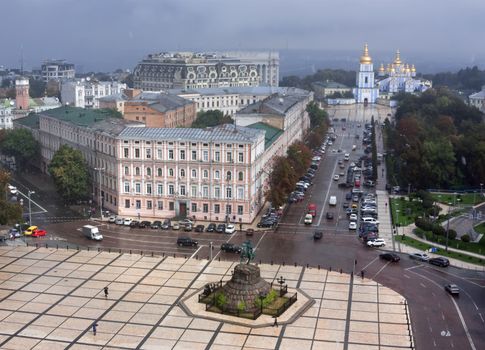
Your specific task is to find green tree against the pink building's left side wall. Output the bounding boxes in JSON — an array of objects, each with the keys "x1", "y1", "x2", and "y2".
[{"x1": 49, "y1": 145, "x2": 90, "y2": 203}]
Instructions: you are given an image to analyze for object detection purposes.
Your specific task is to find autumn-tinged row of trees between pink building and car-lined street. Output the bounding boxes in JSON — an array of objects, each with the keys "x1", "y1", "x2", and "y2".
[{"x1": 266, "y1": 102, "x2": 329, "y2": 207}]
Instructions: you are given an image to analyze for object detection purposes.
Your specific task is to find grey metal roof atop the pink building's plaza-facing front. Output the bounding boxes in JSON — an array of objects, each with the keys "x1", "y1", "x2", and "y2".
[{"x1": 119, "y1": 124, "x2": 264, "y2": 143}]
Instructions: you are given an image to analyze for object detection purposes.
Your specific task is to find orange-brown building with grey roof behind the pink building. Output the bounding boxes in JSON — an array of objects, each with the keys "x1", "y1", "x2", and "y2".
[{"x1": 99, "y1": 89, "x2": 197, "y2": 128}]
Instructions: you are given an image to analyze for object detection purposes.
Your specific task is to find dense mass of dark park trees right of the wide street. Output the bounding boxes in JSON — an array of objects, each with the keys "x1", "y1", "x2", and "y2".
[{"x1": 384, "y1": 88, "x2": 485, "y2": 189}]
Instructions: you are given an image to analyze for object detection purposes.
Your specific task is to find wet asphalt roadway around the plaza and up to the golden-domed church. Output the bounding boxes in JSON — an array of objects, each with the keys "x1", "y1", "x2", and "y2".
[{"x1": 7, "y1": 106, "x2": 485, "y2": 350}]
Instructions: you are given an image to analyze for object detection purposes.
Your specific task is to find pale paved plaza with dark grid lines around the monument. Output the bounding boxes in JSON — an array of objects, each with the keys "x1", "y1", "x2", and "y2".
[{"x1": 0, "y1": 246, "x2": 412, "y2": 350}]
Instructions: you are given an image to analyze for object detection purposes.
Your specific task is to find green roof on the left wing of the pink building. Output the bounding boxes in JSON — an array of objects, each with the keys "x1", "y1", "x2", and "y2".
[{"x1": 37, "y1": 106, "x2": 122, "y2": 126}]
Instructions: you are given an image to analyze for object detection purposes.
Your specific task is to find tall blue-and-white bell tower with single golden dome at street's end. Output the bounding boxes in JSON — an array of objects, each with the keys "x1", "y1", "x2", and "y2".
[{"x1": 354, "y1": 43, "x2": 379, "y2": 103}]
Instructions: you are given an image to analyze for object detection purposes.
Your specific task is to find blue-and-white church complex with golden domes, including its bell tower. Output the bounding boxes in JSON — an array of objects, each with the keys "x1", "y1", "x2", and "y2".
[{"x1": 354, "y1": 44, "x2": 432, "y2": 104}]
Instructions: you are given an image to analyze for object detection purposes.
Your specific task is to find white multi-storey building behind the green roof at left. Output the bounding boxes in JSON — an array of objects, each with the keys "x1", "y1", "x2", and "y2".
[{"x1": 61, "y1": 79, "x2": 126, "y2": 108}]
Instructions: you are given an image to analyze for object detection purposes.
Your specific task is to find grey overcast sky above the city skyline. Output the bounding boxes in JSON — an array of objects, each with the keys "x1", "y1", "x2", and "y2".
[{"x1": 0, "y1": 0, "x2": 485, "y2": 71}]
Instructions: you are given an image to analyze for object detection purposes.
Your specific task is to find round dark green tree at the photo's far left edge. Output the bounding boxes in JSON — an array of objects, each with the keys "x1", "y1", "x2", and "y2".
[{"x1": 0, "y1": 129, "x2": 40, "y2": 169}]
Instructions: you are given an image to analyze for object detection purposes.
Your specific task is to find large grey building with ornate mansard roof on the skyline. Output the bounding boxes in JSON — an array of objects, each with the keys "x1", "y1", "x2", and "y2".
[{"x1": 133, "y1": 52, "x2": 279, "y2": 91}]
